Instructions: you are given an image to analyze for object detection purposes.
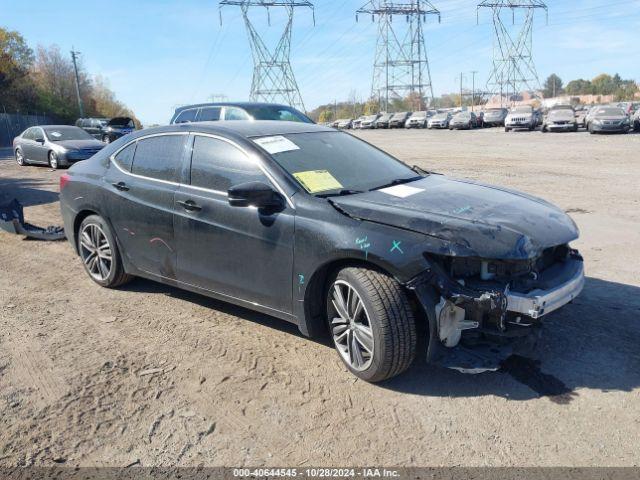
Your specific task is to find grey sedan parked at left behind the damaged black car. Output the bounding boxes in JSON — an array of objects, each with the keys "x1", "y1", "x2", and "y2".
[{"x1": 13, "y1": 125, "x2": 105, "y2": 168}]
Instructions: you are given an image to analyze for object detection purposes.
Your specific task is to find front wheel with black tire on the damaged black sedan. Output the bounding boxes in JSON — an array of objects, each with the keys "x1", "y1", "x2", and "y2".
[{"x1": 326, "y1": 267, "x2": 417, "y2": 383}]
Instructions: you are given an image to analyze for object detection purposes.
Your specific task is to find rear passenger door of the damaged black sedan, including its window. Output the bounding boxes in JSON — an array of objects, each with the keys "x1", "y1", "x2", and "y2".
[{"x1": 104, "y1": 133, "x2": 188, "y2": 279}]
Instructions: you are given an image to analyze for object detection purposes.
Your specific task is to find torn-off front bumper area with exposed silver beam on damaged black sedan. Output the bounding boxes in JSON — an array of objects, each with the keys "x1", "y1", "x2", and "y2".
[{"x1": 406, "y1": 251, "x2": 585, "y2": 373}]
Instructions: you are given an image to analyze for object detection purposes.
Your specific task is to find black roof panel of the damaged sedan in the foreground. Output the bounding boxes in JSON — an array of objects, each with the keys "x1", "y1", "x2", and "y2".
[{"x1": 139, "y1": 120, "x2": 336, "y2": 138}]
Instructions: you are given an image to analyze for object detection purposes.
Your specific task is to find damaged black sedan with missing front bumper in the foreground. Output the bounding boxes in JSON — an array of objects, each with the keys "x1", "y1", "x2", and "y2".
[{"x1": 60, "y1": 121, "x2": 584, "y2": 382}]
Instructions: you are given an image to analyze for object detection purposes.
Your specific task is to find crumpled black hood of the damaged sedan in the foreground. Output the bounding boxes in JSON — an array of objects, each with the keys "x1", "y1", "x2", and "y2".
[{"x1": 331, "y1": 174, "x2": 579, "y2": 260}]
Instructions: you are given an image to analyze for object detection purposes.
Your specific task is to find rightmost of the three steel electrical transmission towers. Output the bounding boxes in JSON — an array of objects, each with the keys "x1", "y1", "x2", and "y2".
[{"x1": 477, "y1": 0, "x2": 548, "y2": 105}]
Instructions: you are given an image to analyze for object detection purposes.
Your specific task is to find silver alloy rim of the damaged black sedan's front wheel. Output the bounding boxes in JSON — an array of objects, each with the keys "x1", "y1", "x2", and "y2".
[{"x1": 329, "y1": 280, "x2": 375, "y2": 371}]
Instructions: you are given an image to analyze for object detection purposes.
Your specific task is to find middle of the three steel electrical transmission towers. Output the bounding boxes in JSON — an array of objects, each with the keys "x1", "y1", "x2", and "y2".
[{"x1": 356, "y1": 0, "x2": 440, "y2": 111}]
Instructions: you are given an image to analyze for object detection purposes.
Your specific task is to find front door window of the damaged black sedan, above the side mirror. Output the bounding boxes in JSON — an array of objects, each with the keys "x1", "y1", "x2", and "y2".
[{"x1": 191, "y1": 135, "x2": 268, "y2": 192}]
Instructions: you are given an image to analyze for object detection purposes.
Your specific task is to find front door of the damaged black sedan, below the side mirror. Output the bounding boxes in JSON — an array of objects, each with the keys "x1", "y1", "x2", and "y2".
[{"x1": 175, "y1": 134, "x2": 294, "y2": 313}]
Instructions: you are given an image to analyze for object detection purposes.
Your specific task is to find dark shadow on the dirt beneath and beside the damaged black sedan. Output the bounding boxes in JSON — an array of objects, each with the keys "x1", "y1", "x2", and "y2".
[{"x1": 123, "y1": 278, "x2": 640, "y2": 404}]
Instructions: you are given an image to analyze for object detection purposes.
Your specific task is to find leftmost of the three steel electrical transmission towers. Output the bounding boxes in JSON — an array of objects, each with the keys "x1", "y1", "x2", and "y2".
[{"x1": 219, "y1": 0, "x2": 315, "y2": 111}]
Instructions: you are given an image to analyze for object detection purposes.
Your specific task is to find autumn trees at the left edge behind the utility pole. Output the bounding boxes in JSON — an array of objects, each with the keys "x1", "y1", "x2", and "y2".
[{"x1": 0, "y1": 28, "x2": 139, "y2": 123}]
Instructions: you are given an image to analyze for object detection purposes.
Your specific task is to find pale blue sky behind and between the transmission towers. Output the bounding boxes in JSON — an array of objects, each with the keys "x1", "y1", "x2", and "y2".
[{"x1": 0, "y1": 0, "x2": 640, "y2": 124}]
